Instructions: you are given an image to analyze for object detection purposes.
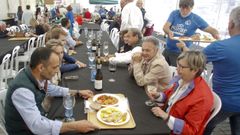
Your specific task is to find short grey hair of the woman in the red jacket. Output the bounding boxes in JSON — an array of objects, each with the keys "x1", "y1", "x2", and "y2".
[{"x1": 177, "y1": 50, "x2": 206, "y2": 77}]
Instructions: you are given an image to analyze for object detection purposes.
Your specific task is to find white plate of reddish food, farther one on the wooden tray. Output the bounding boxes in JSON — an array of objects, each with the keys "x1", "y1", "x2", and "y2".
[{"x1": 93, "y1": 93, "x2": 120, "y2": 107}]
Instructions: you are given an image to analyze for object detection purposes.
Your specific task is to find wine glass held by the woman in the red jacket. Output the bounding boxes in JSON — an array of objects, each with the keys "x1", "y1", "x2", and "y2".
[{"x1": 145, "y1": 81, "x2": 158, "y2": 106}]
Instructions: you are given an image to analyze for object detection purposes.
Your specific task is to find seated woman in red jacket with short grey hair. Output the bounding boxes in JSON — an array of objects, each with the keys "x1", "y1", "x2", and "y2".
[{"x1": 148, "y1": 51, "x2": 213, "y2": 135}]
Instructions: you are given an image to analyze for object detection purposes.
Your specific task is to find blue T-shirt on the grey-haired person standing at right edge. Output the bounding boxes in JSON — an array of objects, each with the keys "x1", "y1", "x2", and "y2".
[{"x1": 204, "y1": 35, "x2": 240, "y2": 111}]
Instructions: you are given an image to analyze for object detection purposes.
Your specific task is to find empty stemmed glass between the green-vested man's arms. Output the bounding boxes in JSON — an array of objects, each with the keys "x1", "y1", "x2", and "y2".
[{"x1": 63, "y1": 94, "x2": 75, "y2": 122}]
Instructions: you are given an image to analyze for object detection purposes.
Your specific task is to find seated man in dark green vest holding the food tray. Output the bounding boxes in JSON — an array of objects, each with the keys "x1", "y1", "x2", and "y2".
[{"x1": 5, "y1": 47, "x2": 97, "y2": 135}]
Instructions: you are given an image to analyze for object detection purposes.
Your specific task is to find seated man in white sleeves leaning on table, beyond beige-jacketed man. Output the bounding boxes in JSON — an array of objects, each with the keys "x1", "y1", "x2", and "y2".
[{"x1": 110, "y1": 28, "x2": 142, "y2": 64}]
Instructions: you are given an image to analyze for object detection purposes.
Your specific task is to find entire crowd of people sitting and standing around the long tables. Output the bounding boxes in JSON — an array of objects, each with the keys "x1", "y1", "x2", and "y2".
[{"x1": 0, "y1": 0, "x2": 240, "y2": 135}]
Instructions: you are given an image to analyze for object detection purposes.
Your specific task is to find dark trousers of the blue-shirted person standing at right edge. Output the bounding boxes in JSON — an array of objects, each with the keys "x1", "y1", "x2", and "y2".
[{"x1": 204, "y1": 109, "x2": 240, "y2": 135}]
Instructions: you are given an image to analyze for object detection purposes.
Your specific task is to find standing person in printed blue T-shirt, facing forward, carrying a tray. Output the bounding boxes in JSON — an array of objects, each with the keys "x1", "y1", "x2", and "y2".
[{"x1": 163, "y1": 0, "x2": 219, "y2": 66}]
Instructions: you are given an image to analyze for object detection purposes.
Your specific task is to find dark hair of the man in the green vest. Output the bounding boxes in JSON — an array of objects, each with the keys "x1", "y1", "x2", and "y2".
[{"x1": 30, "y1": 47, "x2": 55, "y2": 69}]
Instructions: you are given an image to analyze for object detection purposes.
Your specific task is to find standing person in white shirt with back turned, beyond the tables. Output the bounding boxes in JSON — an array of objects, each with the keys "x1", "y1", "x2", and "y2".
[{"x1": 120, "y1": 0, "x2": 143, "y2": 31}]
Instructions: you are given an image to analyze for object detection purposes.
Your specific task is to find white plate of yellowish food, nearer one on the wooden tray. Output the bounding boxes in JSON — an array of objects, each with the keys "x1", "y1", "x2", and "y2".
[{"x1": 97, "y1": 107, "x2": 130, "y2": 126}]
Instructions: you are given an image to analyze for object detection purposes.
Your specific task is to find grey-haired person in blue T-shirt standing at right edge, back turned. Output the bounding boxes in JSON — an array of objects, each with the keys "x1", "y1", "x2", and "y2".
[{"x1": 175, "y1": 6, "x2": 240, "y2": 135}]
